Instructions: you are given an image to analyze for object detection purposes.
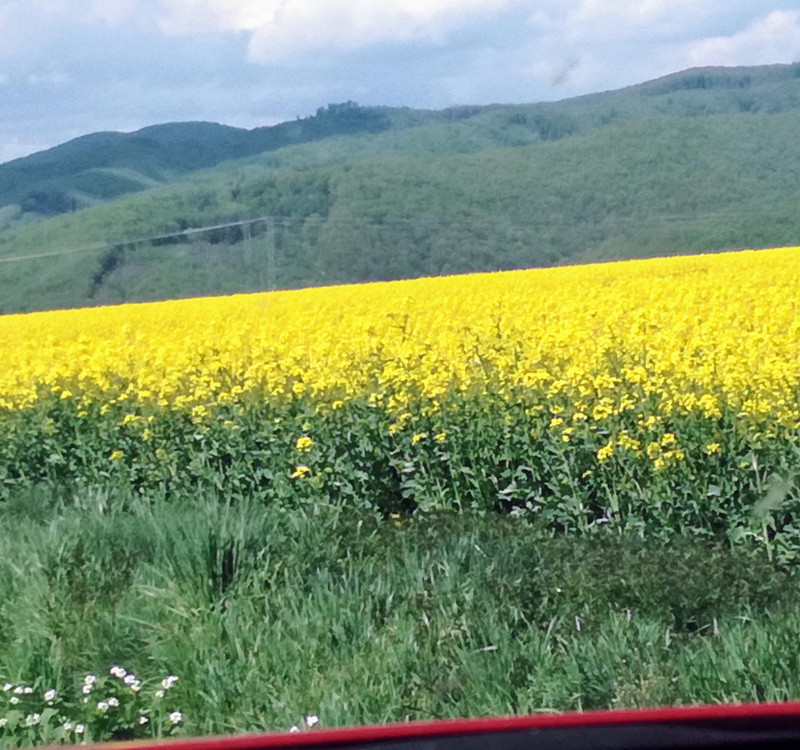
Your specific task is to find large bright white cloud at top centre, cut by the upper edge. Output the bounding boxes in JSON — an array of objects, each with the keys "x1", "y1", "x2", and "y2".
[{"x1": 155, "y1": 0, "x2": 507, "y2": 63}]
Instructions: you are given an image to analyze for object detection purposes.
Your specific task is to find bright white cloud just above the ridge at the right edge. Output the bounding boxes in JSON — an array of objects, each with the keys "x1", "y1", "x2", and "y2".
[{"x1": 689, "y1": 10, "x2": 800, "y2": 65}]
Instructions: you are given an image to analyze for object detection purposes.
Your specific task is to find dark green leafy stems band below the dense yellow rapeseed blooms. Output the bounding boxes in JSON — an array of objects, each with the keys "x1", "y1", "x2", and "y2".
[{"x1": 0, "y1": 392, "x2": 800, "y2": 566}]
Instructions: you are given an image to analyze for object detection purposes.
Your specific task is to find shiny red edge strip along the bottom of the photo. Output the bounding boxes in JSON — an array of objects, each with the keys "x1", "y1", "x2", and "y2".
[{"x1": 95, "y1": 701, "x2": 800, "y2": 750}]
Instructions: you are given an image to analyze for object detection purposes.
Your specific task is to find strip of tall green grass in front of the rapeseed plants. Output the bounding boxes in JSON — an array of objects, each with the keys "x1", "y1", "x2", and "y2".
[{"x1": 0, "y1": 487, "x2": 800, "y2": 745}]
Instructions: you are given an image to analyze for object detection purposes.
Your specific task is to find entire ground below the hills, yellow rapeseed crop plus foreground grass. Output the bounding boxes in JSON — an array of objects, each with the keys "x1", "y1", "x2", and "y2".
[{"x1": 0, "y1": 248, "x2": 800, "y2": 745}]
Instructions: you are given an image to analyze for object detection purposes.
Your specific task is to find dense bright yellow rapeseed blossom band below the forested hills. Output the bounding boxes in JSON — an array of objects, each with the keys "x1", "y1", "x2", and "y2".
[{"x1": 0, "y1": 247, "x2": 800, "y2": 432}]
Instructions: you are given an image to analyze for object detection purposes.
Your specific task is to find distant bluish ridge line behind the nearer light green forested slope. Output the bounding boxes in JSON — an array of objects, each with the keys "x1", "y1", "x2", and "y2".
[{"x1": 6, "y1": 65, "x2": 800, "y2": 223}]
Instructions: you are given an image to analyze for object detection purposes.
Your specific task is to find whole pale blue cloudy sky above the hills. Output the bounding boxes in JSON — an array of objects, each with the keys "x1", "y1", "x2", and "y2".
[{"x1": 0, "y1": 0, "x2": 800, "y2": 162}]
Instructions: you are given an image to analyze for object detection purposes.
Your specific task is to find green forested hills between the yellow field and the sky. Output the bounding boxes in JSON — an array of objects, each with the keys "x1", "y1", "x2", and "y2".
[{"x1": 0, "y1": 65, "x2": 800, "y2": 312}]
